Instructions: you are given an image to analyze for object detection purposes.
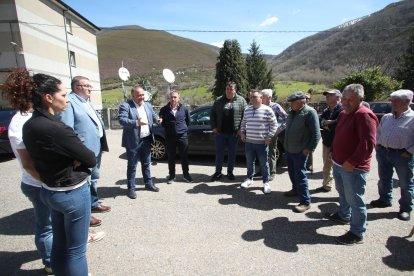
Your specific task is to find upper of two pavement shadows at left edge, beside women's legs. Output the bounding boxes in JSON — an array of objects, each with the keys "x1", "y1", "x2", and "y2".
[{"x1": 0, "y1": 208, "x2": 35, "y2": 235}]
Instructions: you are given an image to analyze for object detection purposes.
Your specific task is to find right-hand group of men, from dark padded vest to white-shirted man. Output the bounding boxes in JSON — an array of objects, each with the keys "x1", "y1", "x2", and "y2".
[{"x1": 211, "y1": 82, "x2": 414, "y2": 245}]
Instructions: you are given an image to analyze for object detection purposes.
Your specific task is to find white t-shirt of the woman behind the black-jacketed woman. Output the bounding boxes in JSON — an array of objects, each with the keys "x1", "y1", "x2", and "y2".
[{"x1": 8, "y1": 111, "x2": 42, "y2": 187}]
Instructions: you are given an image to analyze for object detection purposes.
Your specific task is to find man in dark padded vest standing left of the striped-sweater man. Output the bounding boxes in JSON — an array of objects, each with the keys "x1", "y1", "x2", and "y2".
[{"x1": 210, "y1": 81, "x2": 247, "y2": 181}]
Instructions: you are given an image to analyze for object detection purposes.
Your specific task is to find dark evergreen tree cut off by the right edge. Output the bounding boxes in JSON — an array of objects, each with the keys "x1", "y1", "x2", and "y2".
[{"x1": 396, "y1": 30, "x2": 414, "y2": 90}]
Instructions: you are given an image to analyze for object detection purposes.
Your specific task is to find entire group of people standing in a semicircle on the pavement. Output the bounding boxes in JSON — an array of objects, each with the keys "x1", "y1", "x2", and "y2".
[{"x1": 4, "y1": 69, "x2": 414, "y2": 275}]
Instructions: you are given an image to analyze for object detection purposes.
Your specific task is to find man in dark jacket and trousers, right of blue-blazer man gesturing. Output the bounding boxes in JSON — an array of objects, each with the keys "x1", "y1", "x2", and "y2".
[{"x1": 159, "y1": 90, "x2": 193, "y2": 184}]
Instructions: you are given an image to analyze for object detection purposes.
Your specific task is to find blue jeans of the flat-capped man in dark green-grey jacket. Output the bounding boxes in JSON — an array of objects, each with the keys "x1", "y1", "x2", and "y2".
[{"x1": 286, "y1": 152, "x2": 311, "y2": 205}]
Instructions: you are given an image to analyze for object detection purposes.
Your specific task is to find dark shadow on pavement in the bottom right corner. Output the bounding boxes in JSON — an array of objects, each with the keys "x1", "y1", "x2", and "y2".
[{"x1": 382, "y1": 236, "x2": 414, "y2": 271}]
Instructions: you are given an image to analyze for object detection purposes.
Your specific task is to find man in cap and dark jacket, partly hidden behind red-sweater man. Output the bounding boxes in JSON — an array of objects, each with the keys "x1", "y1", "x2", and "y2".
[{"x1": 319, "y1": 89, "x2": 342, "y2": 192}]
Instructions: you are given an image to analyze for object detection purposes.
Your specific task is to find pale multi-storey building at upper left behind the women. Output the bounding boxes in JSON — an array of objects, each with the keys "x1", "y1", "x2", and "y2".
[{"x1": 0, "y1": 0, "x2": 102, "y2": 109}]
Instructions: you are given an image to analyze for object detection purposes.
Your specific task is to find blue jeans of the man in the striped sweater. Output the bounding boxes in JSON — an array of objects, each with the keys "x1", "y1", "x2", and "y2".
[{"x1": 244, "y1": 142, "x2": 269, "y2": 183}]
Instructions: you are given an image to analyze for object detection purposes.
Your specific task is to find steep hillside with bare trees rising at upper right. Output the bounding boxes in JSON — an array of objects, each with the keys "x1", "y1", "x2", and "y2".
[{"x1": 269, "y1": 0, "x2": 414, "y2": 83}]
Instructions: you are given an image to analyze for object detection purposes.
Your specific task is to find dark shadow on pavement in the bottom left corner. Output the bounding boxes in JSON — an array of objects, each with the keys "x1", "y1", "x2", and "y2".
[{"x1": 0, "y1": 250, "x2": 45, "y2": 276}]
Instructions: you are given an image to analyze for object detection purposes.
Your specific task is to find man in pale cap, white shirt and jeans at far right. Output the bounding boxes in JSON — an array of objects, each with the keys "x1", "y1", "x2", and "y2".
[{"x1": 371, "y1": 90, "x2": 414, "y2": 221}]
